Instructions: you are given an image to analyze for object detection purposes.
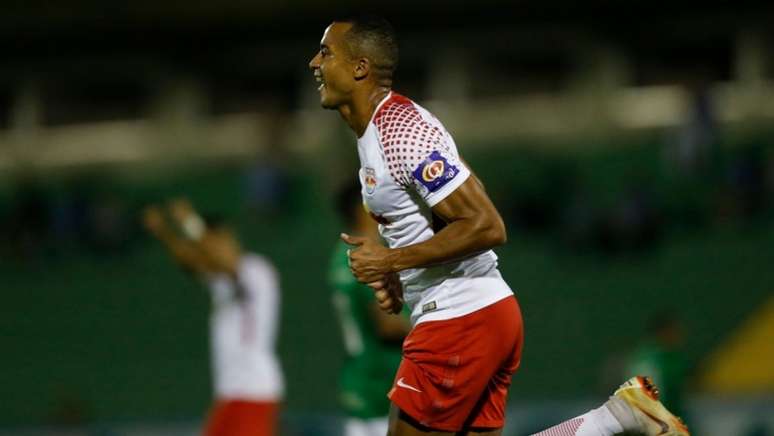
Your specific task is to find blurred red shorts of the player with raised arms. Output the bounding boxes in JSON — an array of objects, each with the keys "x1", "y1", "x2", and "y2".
[{"x1": 204, "y1": 400, "x2": 279, "y2": 436}]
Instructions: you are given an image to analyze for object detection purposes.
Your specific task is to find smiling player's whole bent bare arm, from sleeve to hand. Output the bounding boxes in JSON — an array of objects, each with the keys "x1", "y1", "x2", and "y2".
[{"x1": 342, "y1": 174, "x2": 507, "y2": 289}]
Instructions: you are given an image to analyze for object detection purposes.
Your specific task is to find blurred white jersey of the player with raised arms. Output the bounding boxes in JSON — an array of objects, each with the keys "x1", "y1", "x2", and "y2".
[{"x1": 208, "y1": 254, "x2": 284, "y2": 401}]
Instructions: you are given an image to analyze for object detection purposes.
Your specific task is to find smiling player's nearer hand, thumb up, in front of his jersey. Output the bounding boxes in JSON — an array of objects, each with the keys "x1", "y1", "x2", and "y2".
[{"x1": 341, "y1": 233, "x2": 396, "y2": 284}]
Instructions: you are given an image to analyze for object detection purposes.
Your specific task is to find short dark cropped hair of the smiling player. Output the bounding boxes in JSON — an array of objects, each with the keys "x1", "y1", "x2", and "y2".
[{"x1": 336, "y1": 14, "x2": 398, "y2": 79}]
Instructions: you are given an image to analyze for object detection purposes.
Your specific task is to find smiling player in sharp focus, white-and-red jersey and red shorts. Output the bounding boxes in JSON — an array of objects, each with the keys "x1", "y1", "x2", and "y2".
[{"x1": 309, "y1": 17, "x2": 688, "y2": 436}]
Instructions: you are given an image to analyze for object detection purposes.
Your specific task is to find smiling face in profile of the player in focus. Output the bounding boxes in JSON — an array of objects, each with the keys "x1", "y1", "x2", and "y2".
[{"x1": 309, "y1": 23, "x2": 355, "y2": 109}]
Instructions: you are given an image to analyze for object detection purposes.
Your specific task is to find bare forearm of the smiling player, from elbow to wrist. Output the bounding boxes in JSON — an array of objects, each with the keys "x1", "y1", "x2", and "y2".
[{"x1": 393, "y1": 216, "x2": 506, "y2": 271}]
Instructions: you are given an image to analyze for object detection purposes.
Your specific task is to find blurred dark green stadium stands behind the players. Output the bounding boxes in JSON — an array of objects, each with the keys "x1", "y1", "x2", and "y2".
[{"x1": 0, "y1": 0, "x2": 774, "y2": 436}]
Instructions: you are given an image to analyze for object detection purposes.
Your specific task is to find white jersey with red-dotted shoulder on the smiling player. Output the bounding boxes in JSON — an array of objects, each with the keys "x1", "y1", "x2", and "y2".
[{"x1": 357, "y1": 92, "x2": 513, "y2": 324}]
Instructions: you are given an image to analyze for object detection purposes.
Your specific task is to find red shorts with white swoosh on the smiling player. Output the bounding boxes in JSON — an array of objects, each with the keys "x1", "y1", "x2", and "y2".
[{"x1": 387, "y1": 297, "x2": 524, "y2": 432}]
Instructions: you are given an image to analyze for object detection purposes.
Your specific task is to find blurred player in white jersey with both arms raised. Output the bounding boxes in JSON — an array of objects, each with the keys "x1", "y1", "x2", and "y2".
[{"x1": 143, "y1": 200, "x2": 284, "y2": 436}]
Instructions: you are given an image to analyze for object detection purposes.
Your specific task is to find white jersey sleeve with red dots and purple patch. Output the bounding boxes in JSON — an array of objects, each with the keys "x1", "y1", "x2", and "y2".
[{"x1": 374, "y1": 102, "x2": 470, "y2": 207}]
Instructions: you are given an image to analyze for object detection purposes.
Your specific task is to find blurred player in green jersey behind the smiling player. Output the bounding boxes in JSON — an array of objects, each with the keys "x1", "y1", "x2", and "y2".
[{"x1": 328, "y1": 183, "x2": 409, "y2": 436}]
